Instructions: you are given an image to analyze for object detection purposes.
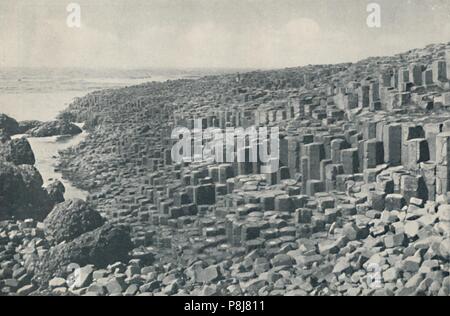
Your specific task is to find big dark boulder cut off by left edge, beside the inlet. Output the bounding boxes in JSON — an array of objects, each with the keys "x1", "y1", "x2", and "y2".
[{"x1": 0, "y1": 159, "x2": 53, "y2": 221}]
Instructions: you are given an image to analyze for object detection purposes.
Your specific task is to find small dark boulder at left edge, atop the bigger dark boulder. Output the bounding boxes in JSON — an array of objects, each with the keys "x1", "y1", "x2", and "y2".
[{"x1": 0, "y1": 138, "x2": 36, "y2": 165}]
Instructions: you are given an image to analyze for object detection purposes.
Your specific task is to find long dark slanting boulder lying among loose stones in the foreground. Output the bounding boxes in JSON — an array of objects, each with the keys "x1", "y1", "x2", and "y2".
[{"x1": 34, "y1": 224, "x2": 133, "y2": 285}]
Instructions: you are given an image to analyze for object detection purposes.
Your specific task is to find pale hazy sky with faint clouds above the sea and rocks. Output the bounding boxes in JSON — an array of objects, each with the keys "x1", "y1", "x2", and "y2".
[{"x1": 0, "y1": 0, "x2": 450, "y2": 69}]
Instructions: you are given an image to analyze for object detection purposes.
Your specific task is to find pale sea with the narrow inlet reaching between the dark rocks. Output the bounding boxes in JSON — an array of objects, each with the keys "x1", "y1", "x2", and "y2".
[{"x1": 0, "y1": 68, "x2": 202, "y2": 200}]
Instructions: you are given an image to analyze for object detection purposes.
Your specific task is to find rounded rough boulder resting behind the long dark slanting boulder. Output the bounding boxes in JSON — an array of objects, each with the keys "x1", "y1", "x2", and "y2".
[{"x1": 44, "y1": 199, "x2": 104, "y2": 243}]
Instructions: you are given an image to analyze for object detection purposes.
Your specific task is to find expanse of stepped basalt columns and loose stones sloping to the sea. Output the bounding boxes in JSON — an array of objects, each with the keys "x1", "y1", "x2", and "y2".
[{"x1": 2, "y1": 45, "x2": 450, "y2": 295}]
